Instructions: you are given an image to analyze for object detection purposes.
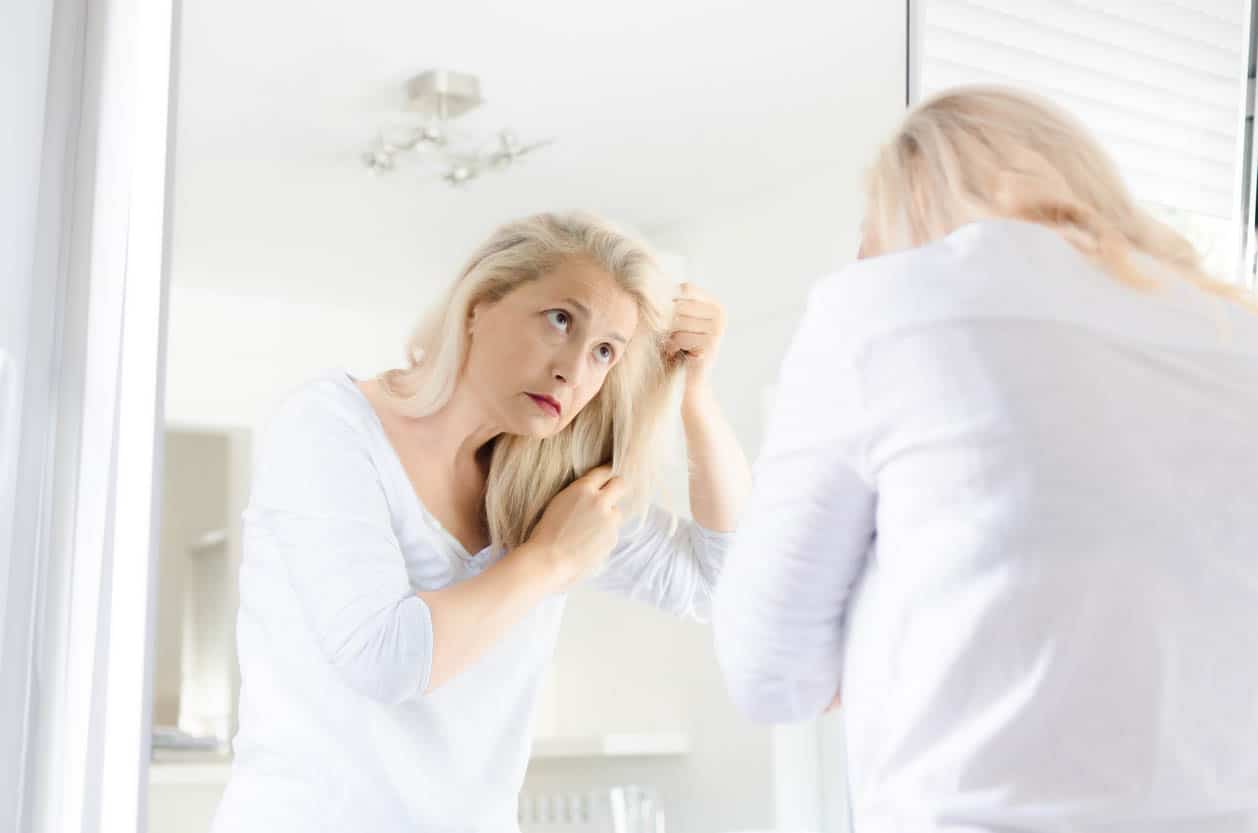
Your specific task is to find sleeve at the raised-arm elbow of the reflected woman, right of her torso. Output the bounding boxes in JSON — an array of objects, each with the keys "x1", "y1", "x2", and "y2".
[{"x1": 591, "y1": 505, "x2": 733, "y2": 622}]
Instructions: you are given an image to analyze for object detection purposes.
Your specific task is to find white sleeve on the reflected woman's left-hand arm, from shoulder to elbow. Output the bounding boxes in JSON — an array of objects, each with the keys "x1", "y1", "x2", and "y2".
[{"x1": 245, "y1": 391, "x2": 433, "y2": 702}]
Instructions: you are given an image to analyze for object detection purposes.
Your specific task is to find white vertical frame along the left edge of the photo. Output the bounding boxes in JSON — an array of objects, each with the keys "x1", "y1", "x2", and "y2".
[{"x1": 10, "y1": 0, "x2": 179, "y2": 833}]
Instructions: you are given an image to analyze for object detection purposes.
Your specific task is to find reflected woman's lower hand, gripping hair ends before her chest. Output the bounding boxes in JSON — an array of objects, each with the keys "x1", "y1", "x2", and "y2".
[{"x1": 526, "y1": 466, "x2": 625, "y2": 590}]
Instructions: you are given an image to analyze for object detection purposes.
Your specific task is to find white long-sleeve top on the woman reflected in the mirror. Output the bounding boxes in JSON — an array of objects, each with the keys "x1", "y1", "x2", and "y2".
[{"x1": 214, "y1": 371, "x2": 727, "y2": 833}]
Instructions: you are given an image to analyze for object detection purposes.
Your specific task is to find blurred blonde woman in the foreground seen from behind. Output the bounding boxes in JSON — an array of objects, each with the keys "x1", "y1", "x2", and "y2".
[{"x1": 713, "y1": 88, "x2": 1258, "y2": 833}]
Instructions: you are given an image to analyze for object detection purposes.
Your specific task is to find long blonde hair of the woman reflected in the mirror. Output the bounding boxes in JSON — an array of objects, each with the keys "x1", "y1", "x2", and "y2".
[{"x1": 380, "y1": 214, "x2": 677, "y2": 549}]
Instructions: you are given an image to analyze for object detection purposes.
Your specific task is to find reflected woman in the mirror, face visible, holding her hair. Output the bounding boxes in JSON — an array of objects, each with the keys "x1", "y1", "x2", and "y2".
[{"x1": 215, "y1": 215, "x2": 750, "y2": 833}]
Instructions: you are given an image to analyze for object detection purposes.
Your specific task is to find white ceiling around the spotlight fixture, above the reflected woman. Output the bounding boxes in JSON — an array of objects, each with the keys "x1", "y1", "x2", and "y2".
[{"x1": 174, "y1": 0, "x2": 903, "y2": 300}]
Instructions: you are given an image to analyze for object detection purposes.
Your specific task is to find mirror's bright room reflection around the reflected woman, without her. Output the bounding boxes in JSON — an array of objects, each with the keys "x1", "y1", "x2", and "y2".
[{"x1": 150, "y1": 0, "x2": 907, "y2": 833}]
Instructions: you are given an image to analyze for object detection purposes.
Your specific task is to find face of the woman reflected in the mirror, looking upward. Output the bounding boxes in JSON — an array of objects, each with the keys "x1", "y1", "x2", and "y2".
[{"x1": 463, "y1": 258, "x2": 638, "y2": 437}]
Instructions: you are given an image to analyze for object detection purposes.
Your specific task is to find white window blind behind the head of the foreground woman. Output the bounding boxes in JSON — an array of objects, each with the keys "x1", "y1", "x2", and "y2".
[{"x1": 918, "y1": 0, "x2": 1248, "y2": 218}]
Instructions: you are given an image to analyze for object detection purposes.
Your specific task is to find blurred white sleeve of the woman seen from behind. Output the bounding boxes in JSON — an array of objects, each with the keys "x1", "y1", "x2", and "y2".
[{"x1": 712, "y1": 282, "x2": 874, "y2": 722}]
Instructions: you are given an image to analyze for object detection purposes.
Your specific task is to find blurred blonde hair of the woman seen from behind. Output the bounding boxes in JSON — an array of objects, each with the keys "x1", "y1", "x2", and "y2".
[{"x1": 864, "y1": 86, "x2": 1258, "y2": 311}]
